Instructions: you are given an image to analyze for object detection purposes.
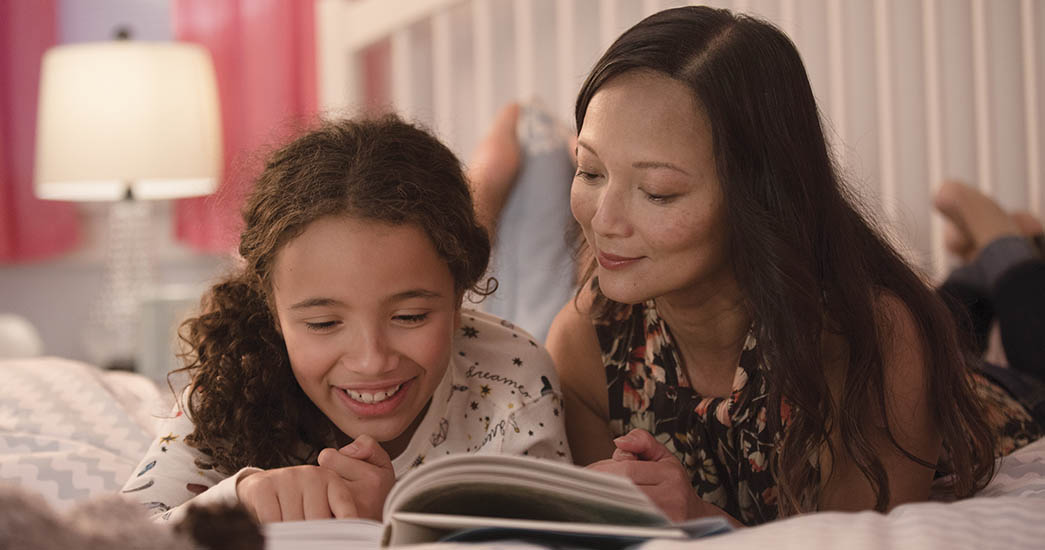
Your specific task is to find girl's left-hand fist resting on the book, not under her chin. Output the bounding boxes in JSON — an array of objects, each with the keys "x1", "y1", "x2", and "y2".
[{"x1": 236, "y1": 465, "x2": 356, "y2": 523}]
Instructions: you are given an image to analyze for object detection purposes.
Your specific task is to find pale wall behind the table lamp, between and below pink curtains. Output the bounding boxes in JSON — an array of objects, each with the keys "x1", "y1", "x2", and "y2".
[{"x1": 0, "y1": 0, "x2": 227, "y2": 368}]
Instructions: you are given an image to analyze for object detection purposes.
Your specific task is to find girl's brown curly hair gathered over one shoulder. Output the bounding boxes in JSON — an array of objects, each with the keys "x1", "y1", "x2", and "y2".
[{"x1": 176, "y1": 115, "x2": 496, "y2": 474}]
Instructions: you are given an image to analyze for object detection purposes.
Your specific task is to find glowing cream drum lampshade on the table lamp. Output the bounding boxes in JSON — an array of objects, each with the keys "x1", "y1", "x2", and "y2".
[{"x1": 34, "y1": 40, "x2": 222, "y2": 201}]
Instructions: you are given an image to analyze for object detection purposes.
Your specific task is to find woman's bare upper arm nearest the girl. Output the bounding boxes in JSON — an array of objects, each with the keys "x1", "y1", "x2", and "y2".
[{"x1": 547, "y1": 295, "x2": 614, "y2": 465}]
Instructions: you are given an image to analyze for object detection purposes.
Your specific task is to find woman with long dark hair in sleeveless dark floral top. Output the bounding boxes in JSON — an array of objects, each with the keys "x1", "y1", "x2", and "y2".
[{"x1": 548, "y1": 6, "x2": 1041, "y2": 531}]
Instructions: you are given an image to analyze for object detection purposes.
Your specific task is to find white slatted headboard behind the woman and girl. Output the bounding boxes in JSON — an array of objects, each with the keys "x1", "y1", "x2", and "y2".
[{"x1": 317, "y1": 0, "x2": 1045, "y2": 282}]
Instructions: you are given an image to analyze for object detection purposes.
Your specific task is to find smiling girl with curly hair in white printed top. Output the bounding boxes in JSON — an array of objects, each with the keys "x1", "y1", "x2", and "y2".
[{"x1": 123, "y1": 116, "x2": 570, "y2": 522}]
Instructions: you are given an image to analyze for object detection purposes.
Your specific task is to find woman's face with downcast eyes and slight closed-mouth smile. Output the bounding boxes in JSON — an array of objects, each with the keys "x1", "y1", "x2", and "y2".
[{"x1": 570, "y1": 71, "x2": 733, "y2": 303}]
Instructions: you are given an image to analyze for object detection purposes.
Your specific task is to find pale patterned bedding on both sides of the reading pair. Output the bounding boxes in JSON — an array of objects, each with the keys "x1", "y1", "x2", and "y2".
[{"x1": 0, "y1": 358, "x2": 1045, "y2": 550}]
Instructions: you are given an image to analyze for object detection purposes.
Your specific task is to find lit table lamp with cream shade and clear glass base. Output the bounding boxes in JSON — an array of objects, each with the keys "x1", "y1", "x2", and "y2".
[{"x1": 33, "y1": 40, "x2": 222, "y2": 367}]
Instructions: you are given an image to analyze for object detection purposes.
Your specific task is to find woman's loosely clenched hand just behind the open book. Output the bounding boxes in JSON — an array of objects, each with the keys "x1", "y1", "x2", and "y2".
[{"x1": 587, "y1": 430, "x2": 739, "y2": 526}]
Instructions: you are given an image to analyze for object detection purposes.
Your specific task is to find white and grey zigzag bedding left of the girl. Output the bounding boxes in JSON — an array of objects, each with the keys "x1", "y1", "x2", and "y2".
[{"x1": 0, "y1": 358, "x2": 171, "y2": 509}]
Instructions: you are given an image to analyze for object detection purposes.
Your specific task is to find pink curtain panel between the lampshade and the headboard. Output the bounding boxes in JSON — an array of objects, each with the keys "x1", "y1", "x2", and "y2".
[{"x1": 173, "y1": 0, "x2": 317, "y2": 252}]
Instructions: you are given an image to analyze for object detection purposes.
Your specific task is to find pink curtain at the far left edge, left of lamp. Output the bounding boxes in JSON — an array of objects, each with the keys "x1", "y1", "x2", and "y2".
[{"x1": 0, "y1": 0, "x2": 79, "y2": 262}]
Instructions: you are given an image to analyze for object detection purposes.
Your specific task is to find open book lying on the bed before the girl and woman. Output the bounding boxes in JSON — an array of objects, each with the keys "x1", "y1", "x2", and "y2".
[{"x1": 265, "y1": 454, "x2": 730, "y2": 550}]
